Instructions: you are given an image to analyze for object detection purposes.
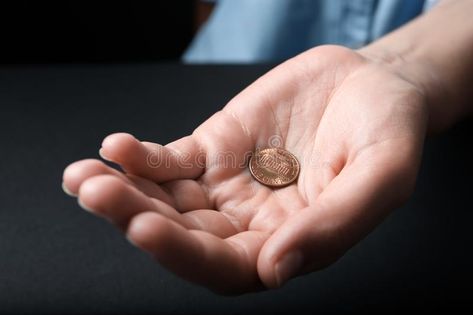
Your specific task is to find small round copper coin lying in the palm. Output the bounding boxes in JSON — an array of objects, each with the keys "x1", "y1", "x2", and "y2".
[{"x1": 249, "y1": 148, "x2": 300, "y2": 187}]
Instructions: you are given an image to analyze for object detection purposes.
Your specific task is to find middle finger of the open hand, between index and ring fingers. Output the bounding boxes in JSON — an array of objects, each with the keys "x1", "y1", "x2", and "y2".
[{"x1": 78, "y1": 175, "x2": 188, "y2": 229}]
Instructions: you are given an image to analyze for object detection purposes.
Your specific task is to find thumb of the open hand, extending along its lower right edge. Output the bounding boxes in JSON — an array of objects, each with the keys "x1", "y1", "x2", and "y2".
[{"x1": 258, "y1": 142, "x2": 420, "y2": 287}]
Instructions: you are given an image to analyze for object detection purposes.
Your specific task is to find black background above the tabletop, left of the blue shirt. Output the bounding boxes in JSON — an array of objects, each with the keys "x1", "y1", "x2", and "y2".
[{"x1": 0, "y1": 0, "x2": 195, "y2": 64}]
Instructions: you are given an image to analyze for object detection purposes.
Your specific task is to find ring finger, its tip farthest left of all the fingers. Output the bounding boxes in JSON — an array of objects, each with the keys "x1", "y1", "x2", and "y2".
[{"x1": 63, "y1": 159, "x2": 173, "y2": 206}]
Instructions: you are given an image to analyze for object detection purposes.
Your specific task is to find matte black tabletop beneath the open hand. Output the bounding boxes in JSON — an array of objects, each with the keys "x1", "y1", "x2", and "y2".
[{"x1": 0, "y1": 64, "x2": 473, "y2": 314}]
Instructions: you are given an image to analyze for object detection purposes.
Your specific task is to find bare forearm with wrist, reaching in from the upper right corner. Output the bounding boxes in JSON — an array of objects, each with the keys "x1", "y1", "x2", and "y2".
[{"x1": 360, "y1": 0, "x2": 473, "y2": 132}]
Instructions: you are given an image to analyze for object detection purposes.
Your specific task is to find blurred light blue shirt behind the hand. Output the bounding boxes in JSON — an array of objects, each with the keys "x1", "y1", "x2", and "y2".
[{"x1": 183, "y1": 0, "x2": 435, "y2": 63}]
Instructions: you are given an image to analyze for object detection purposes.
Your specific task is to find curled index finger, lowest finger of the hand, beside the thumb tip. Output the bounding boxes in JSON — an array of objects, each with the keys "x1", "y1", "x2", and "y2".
[{"x1": 127, "y1": 212, "x2": 265, "y2": 293}]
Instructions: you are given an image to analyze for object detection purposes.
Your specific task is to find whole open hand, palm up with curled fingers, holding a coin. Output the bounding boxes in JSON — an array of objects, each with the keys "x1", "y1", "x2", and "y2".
[{"x1": 63, "y1": 46, "x2": 428, "y2": 293}]
